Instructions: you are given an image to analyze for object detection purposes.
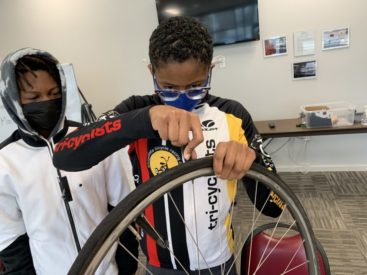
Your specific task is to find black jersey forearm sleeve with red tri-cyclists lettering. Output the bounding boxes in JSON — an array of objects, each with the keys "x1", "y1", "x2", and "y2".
[{"x1": 53, "y1": 108, "x2": 158, "y2": 171}]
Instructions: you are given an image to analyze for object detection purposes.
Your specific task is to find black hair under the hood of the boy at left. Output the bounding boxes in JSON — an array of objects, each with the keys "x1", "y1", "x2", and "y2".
[{"x1": 15, "y1": 55, "x2": 61, "y2": 91}]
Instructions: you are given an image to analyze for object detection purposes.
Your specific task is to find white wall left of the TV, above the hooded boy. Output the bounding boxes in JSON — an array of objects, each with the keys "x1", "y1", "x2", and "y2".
[{"x1": 0, "y1": 0, "x2": 158, "y2": 114}]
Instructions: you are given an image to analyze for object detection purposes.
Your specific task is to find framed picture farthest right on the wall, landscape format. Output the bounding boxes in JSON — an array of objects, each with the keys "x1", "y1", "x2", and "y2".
[{"x1": 322, "y1": 28, "x2": 349, "y2": 50}]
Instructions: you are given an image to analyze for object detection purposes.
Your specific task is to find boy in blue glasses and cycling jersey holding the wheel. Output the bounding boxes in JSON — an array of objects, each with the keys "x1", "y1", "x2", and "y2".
[{"x1": 55, "y1": 17, "x2": 280, "y2": 274}]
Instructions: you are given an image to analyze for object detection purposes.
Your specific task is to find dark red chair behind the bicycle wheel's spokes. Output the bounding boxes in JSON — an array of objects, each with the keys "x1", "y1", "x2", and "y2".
[{"x1": 240, "y1": 223, "x2": 330, "y2": 275}]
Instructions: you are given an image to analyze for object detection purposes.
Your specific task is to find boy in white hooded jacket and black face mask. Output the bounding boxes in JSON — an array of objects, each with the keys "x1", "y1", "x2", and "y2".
[{"x1": 0, "y1": 48, "x2": 130, "y2": 275}]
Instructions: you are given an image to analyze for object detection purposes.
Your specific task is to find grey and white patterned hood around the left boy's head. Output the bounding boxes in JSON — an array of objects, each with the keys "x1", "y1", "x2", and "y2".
[{"x1": 0, "y1": 48, "x2": 66, "y2": 139}]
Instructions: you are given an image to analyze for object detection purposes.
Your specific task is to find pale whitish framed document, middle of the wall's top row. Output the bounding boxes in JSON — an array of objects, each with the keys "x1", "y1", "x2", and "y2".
[{"x1": 293, "y1": 31, "x2": 315, "y2": 56}]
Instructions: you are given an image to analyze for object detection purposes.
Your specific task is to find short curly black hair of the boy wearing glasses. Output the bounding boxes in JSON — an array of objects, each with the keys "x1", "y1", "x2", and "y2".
[{"x1": 149, "y1": 16, "x2": 213, "y2": 68}]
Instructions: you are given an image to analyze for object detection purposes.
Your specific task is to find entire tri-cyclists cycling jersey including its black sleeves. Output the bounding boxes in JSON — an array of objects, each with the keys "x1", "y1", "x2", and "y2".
[{"x1": 54, "y1": 98, "x2": 280, "y2": 270}]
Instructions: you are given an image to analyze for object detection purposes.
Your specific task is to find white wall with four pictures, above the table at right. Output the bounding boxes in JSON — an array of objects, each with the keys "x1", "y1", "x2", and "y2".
[{"x1": 214, "y1": 0, "x2": 367, "y2": 120}]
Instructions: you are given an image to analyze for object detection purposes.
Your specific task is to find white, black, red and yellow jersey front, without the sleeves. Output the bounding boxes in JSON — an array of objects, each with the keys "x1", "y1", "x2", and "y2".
[{"x1": 130, "y1": 104, "x2": 247, "y2": 270}]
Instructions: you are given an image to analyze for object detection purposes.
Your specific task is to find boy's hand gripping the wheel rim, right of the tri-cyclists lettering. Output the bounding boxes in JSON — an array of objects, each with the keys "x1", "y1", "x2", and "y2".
[{"x1": 213, "y1": 141, "x2": 256, "y2": 179}]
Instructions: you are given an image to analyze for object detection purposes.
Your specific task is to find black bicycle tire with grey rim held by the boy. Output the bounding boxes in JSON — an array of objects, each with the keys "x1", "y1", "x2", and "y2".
[{"x1": 68, "y1": 157, "x2": 319, "y2": 275}]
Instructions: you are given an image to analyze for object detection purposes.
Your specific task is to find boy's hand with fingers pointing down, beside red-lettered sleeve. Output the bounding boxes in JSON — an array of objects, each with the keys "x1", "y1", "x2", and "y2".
[{"x1": 149, "y1": 105, "x2": 204, "y2": 160}]
